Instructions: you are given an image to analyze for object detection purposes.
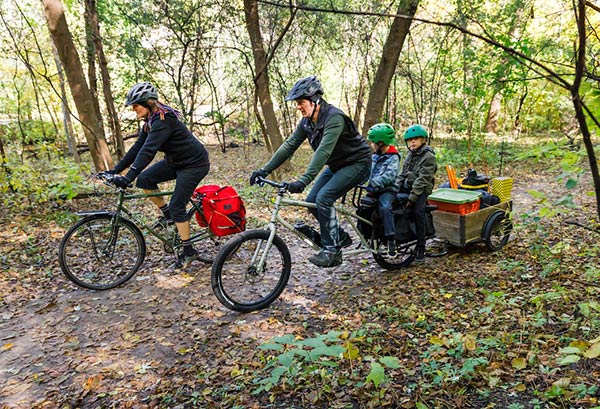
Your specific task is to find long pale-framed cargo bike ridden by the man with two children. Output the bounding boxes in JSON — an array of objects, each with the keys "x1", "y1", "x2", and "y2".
[{"x1": 211, "y1": 178, "x2": 437, "y2": 312}]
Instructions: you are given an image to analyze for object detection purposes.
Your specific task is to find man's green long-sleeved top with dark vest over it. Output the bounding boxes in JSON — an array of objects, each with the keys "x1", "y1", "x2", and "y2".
[{"x1": 263, "y1": 100, "x2": 371, "y2": 185}]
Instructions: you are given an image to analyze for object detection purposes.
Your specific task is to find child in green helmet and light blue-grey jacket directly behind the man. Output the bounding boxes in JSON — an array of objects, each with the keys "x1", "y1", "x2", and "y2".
[{"x1": 367, "y1": 123, "x2": 400, "y2": 256}]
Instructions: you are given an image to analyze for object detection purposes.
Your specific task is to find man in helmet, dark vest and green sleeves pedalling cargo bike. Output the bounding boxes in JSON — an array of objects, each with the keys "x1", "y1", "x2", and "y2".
[{"x1": 250, "y1": 76, "x2": 371, "y2": 267}]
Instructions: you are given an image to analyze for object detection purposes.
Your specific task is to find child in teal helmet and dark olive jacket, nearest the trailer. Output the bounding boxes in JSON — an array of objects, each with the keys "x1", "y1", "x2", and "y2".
[{"x1": 396, "y1": 125, "x2": 437, "y2": 263}]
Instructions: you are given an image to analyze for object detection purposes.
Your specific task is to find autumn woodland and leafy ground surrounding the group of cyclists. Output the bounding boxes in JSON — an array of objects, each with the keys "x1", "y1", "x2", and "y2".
[{"x1": 0, "y1": 0, "x2": 600, "y2": 409}]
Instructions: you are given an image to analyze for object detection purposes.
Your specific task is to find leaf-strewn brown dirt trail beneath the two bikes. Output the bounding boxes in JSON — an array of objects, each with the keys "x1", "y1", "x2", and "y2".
[{"x1": 0, "y1": 147, "x2": 592, "y2": 408}]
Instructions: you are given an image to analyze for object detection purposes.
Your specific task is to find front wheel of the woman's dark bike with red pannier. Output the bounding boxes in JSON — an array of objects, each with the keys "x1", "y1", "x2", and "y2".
[{"x1": 58, "y1": 214, "x2": 146, "y2": 290}]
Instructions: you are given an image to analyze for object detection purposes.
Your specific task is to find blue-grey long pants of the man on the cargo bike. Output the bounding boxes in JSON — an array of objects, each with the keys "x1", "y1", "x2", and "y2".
[{"x1": 306, "y1": 159, "x2": 371, "y2": 252}]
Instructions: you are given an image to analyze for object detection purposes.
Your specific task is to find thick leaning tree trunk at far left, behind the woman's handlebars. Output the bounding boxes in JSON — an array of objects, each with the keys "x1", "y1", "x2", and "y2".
[{"x1": 42, "y1": 0, "x2": 113, "y2": 171}]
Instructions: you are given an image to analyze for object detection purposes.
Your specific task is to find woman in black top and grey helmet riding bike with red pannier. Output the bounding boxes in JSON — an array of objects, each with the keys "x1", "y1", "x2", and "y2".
[{"x1": 101, "y1": 82, "x2": 210, "y2": 267}]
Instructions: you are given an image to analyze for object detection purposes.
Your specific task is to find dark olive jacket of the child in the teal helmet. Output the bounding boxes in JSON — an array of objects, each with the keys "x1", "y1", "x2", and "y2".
[{"x1": 396, "y1": 145, "x2": 437, "y2": 203}]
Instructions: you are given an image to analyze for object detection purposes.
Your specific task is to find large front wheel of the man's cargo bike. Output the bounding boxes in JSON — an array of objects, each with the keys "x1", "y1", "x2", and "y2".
[{"x1": 211, "y1": 230, "x2": 292, "y2": 312}]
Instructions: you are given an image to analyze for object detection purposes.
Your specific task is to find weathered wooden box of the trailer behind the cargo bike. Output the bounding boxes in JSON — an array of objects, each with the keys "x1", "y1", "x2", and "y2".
[{"x1": 431, "y1": 201, "x2": 512, "y2": 246}]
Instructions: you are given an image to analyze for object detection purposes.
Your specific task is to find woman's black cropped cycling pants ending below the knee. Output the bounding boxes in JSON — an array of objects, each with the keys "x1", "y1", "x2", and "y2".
[{"x1": 136, "y1": 159, "x2": 210, "y2": 223}]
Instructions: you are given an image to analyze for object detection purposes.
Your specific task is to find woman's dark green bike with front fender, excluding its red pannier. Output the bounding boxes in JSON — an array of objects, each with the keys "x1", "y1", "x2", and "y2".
[{"x1": 58, "y1": 174, "x2": 221, "y2": 290}]
